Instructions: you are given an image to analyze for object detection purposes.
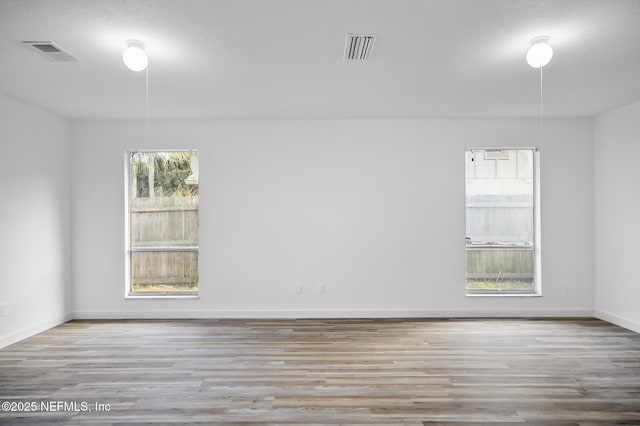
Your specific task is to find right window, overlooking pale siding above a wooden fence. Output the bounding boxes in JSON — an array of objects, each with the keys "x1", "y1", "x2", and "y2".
[{"x1": 465, "y1": 149, "x2": 540, "y2": 294}]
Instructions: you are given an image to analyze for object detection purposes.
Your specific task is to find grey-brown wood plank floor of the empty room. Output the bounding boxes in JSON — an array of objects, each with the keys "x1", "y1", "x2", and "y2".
[{"x1": 0, "y1": 319, "x2": 640, "y2": 425}]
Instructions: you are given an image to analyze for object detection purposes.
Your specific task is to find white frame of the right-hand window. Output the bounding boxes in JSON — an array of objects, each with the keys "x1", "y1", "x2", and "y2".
[{"x1": 464, "y1": 146, "x2": 542, "y2": 297}]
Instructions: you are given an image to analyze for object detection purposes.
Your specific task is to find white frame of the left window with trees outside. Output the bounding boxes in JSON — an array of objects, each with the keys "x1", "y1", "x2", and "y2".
[{"x1": 124, "y1": 148, "x2": 200, "y2": 299}]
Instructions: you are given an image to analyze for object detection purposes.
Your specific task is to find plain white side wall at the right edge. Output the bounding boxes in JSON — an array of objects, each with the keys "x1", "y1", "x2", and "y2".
[{"x1": 594, "y1": 102, "x2": 640, "y2": 333}]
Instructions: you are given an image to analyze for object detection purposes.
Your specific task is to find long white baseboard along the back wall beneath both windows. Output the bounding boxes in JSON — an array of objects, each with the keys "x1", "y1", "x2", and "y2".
[{"x1": 73, "y1": 309, "x2": 594, "y2": 319}]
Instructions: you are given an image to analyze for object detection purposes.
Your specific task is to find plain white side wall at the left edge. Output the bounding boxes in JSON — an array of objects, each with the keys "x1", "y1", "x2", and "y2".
[{"x1": 0, "y1": 95, "x2": 71, "y2": 347}]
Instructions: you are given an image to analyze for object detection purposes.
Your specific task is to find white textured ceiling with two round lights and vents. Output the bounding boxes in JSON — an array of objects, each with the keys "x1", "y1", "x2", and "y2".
[{"x1": 0, "y1": 0, "x2": 640, "y2": 119}]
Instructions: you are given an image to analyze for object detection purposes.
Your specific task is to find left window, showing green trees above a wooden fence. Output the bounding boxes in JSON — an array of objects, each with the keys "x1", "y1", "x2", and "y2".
[{"x1": 126, "y1": 151, "x2": 199, "y2": 296}]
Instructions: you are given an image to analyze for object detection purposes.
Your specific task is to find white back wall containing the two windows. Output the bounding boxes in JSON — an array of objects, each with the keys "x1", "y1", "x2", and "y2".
[{"x1": 72, "y1": 119, "x2": 594, "y2": 318}]
